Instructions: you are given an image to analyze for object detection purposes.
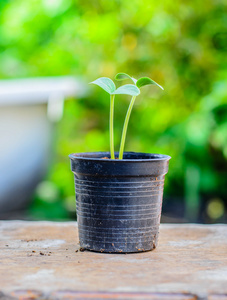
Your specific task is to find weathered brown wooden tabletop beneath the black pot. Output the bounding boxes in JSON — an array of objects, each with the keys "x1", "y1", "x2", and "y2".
[{"x1": 0, "y1": 221, "x2": 227, "y2": 300}]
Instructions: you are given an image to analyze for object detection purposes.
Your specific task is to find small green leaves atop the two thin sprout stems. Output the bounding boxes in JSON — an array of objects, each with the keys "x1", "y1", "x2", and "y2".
[{"x1": 91, "y1": 73, "x2": 164, "y2": 96}]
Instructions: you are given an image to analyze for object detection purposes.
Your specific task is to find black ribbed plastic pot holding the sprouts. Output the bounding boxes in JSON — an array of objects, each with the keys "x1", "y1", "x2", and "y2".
[{"x1": 69, "y1": 152, "x2": 170, "y2": 253}]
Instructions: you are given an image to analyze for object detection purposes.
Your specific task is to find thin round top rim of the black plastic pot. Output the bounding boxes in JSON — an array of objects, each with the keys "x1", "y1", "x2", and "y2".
[{"x1": 69, "y1": 151, "x2": 171, "y2": 164}]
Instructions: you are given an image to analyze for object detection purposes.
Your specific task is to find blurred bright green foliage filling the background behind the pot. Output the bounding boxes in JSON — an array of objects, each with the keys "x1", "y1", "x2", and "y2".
[{"x1": 0, "y1": 0, "x2": 227, "y2": 223}]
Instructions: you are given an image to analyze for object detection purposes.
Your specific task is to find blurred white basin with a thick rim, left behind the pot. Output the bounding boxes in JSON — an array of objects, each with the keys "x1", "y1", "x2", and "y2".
[{"x1": 0, "y1": 76, "x2": 86, "y2": 216}]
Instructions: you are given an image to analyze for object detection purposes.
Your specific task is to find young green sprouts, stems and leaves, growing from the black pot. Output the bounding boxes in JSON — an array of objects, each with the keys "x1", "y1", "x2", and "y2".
[{"x1": 91, "y1": 73, "x2": 163, "y2": 159}]
